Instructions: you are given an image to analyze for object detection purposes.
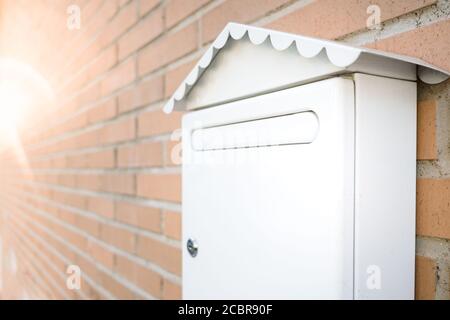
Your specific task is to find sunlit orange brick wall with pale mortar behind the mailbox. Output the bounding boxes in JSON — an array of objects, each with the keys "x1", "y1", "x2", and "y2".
[{"x1": 0, "y1": 0, "x2": 450, "y2": 299}]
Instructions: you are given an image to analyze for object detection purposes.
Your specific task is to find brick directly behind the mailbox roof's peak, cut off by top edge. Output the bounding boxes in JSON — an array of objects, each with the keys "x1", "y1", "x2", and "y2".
[{"x1": 201, "y1": 0, "x2": 288, "y2": 43}]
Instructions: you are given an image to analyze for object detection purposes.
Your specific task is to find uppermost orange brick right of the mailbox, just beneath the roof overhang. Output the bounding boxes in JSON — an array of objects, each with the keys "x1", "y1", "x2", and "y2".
[{"x1": 417, "y1": 100, "x2": 437, "y2": 160}]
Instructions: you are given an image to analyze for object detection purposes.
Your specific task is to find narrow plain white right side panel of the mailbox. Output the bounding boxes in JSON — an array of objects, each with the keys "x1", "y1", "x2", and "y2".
[{"x1": 355, "y1": 74, "x2": 417, "y2": 299}]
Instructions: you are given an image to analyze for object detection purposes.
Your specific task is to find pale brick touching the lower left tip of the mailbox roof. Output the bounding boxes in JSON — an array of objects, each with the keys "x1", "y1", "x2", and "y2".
[{"x1": 138, "y1": 110, "x2": 183, "y2": 137}]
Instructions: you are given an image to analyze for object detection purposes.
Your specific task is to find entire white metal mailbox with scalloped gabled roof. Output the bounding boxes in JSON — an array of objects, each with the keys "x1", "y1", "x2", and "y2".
[{"x1": 165, "y1": 23, "x2": 447, "y2": 299}]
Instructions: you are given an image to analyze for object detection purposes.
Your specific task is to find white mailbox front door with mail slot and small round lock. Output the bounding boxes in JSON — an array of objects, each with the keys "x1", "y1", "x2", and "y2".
[{"x1": 182, "y1": 78, "x2": 354, "y2": 299}]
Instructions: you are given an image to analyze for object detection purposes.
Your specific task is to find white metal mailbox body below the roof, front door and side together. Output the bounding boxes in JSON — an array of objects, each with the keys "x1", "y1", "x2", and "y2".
[{"x1": 183, "y1": 75, "x2": 415, "y2": 299}]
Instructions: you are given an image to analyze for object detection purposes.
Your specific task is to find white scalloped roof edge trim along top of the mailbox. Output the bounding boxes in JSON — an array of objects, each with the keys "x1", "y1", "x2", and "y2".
[{"x1": 163, "y1": 22, "x2": 450, "y2": 113}]
